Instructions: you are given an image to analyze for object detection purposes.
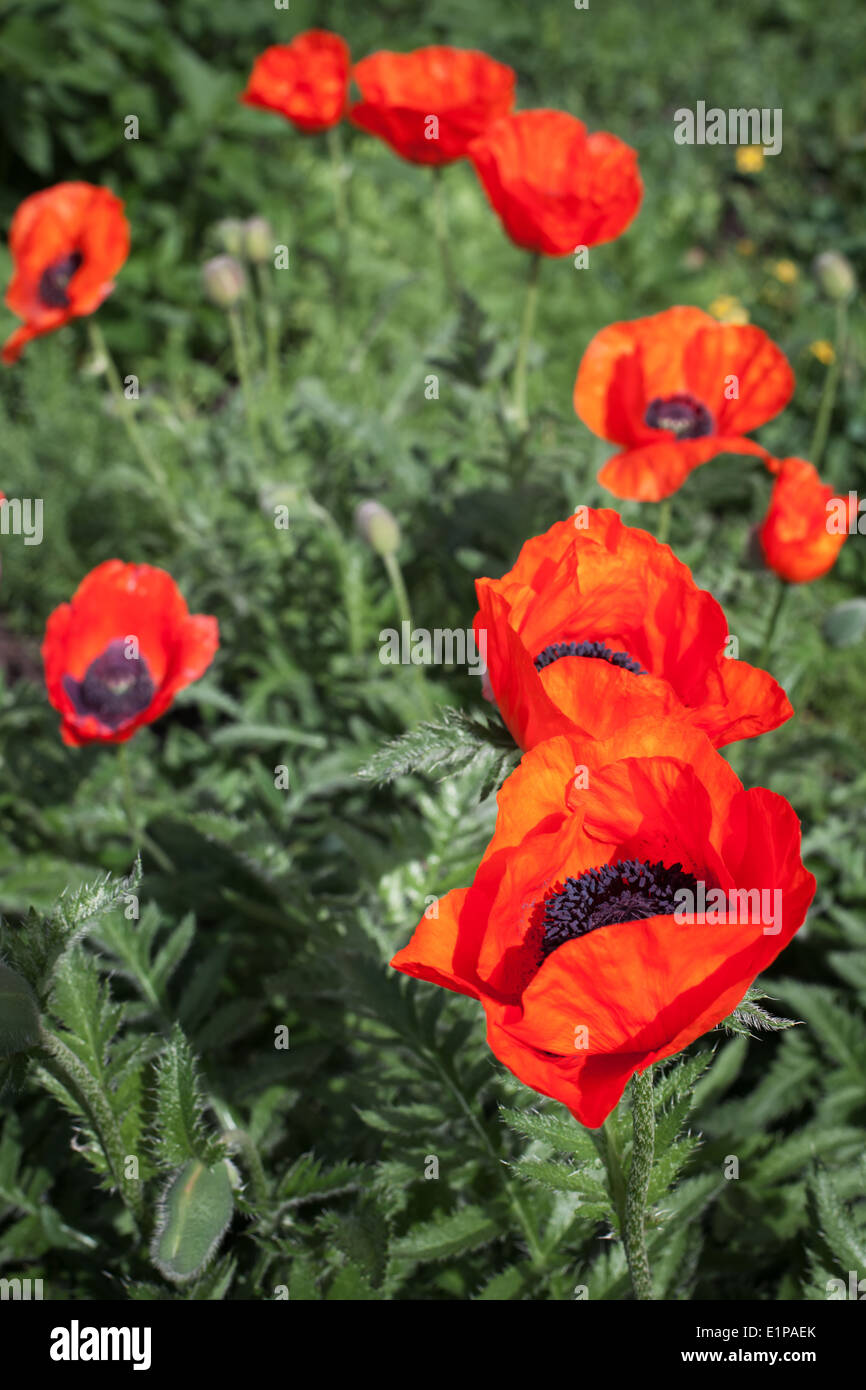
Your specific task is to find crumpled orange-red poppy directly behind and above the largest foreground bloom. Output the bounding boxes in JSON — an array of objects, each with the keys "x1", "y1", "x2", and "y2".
[{"x1": 475, "y1": 507, "x2": 792, "y2": 748}]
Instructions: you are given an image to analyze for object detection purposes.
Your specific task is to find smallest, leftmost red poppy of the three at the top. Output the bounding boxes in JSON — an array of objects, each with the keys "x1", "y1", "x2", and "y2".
[{"x1": 240, "y1": 29, "x2": 352, "y2": 135}]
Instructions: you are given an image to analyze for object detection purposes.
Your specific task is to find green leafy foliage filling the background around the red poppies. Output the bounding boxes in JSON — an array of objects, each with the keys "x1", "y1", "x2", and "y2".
[{"x1": 0, "y1": 0, "x2": 866, "y2": 1300}]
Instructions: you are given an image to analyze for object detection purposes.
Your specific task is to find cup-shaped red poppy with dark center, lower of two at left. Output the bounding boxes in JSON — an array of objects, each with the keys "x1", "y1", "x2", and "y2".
[{"x1": 42, "y1": 560, "x2": 218, "y2": 744}]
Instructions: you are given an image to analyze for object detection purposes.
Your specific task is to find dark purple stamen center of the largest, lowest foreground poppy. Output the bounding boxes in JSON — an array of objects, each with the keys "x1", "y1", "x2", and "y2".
[{"x1": 535, "y1": 859, "x2": 698, "y2": 960}]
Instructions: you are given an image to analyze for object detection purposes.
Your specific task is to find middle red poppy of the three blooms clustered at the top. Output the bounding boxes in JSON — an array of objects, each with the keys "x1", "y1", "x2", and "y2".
[{"x1": 349, "y1": 46, "x2": 516, "y2": 164}]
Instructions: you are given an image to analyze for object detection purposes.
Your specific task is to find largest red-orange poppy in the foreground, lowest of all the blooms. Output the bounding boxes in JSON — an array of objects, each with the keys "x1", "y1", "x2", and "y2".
[{"x1": 391, "y1": 719, "x2": 815, "y2": 1127}]
